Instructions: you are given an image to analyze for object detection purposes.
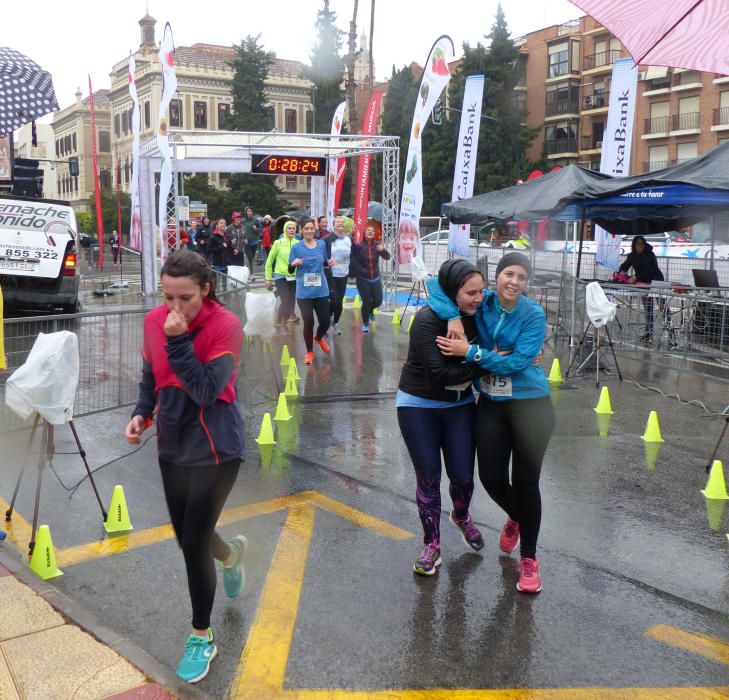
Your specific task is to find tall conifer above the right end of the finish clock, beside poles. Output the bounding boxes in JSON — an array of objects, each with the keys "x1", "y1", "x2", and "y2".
[{"x1": 306, "y1": 0, "x2": 344, "y2": 134}]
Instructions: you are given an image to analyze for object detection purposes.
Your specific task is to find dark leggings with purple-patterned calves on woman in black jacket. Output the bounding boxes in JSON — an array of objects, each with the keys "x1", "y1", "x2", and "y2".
[{"x1": 397, "y1": 403, "x2": 476, "y2": 546}]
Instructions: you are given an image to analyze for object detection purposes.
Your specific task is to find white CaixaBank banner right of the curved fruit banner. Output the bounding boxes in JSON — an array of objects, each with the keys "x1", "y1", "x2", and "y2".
[{"x1": 448, "y1": 75, "x2": 485, "y2": 258}]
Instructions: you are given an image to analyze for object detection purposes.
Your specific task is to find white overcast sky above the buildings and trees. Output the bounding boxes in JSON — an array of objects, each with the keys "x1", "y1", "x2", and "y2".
[{"x1": 7, "y1": 0, "x2": 582, "y2": 108}]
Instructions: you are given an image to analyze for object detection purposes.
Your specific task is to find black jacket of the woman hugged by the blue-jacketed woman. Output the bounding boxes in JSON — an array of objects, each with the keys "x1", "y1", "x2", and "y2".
[{"x1": 398, "y1": 306, "x2": 485, "y2": 402}]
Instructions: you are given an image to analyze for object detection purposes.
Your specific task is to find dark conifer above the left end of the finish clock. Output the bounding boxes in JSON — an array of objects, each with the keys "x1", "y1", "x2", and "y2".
[{"x1": 225, "y1": 34, "x2": 274, "y2": 131}]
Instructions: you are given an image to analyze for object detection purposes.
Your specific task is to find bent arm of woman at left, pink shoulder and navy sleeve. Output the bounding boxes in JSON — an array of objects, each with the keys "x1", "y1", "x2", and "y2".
[{"x1": 165, "y1": 319, "x2": 242, "y2": 408}]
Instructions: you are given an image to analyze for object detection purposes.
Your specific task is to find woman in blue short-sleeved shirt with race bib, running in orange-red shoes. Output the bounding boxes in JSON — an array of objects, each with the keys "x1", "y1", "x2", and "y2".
[{"x1": 289, "y1": 219, "x2": 336, "y2": 365}]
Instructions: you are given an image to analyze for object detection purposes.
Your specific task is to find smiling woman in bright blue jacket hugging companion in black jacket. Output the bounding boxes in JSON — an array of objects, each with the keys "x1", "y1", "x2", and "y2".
[{"x1": 428, "y1": 253, "x2": 554, "y2": 593}]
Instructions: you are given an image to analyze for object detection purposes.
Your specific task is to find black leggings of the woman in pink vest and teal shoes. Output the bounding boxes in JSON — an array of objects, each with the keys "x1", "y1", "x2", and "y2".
[{"x1": 159, "y1": 459, "x2": 240, "y2": 630}]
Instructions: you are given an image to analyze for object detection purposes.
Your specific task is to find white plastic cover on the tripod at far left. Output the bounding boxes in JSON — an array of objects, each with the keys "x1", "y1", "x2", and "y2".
[{"x1": 5, "y1": 331, "x2": 80, "y2": 425}]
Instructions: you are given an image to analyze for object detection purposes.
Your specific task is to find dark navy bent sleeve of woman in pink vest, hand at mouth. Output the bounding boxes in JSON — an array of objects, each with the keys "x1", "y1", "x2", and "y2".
[{"x1": 165, "y1": 333, "x2": 235, "y2": 408}]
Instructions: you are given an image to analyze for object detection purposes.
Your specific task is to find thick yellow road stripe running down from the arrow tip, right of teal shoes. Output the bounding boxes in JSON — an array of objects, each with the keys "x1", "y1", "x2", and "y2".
[{"x1": 231, "y1": 505, "x2": 316, "y2": 698}]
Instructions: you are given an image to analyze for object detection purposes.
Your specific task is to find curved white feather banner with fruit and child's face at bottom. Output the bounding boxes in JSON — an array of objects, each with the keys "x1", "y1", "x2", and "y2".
[{"x1": 397, "y1": 35, "x2": 455, "y2": 264}]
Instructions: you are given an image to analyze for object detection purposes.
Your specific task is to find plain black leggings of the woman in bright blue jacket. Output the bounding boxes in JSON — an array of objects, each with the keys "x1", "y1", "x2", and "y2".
[{"x1": 476, "y1": 396, "x2": 554, "y2": 558}]
